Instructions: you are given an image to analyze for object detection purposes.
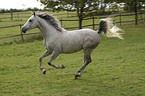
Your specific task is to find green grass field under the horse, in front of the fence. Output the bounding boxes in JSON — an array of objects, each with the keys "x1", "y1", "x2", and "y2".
[{"x1": 0, "y1": 24, "x2": 145, "y2": 96}]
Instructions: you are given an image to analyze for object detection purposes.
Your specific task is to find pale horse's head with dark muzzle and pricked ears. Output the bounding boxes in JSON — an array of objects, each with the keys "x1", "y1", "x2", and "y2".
[{"x1": 21, "y1": 12, "x2": 38, "y2": 33}]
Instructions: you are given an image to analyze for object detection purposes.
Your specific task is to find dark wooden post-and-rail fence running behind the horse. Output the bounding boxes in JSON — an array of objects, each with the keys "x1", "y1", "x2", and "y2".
[{"x1": 0, "y1": 13, "x2": 145, "y2": 41}]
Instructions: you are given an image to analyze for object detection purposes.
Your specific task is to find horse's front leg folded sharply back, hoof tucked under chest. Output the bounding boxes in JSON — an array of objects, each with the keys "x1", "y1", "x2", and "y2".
[{"x1": 48, "y1": 51, "x2": 65, "y2": 69}]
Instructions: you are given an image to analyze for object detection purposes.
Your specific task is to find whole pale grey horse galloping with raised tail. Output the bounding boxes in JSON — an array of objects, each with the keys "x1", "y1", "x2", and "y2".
[{"x1": 21, "y1": 12, "x2": 123, "y2": 79}]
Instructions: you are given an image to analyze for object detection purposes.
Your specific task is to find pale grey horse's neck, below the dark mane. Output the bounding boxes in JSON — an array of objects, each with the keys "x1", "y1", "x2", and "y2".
[{"x1": 38, "y1": 18, "x2": 58, "y2": 40}]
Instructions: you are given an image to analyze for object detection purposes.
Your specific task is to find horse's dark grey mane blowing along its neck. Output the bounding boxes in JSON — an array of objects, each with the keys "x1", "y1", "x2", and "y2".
[{"x1": 37, "y1": 13, "x2": 62, "y2": 32}]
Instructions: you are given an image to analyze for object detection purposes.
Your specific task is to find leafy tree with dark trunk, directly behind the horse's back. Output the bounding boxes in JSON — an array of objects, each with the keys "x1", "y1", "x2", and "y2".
[{"x1": 38, "y1": 0, "x2": 109, "y2": 29}]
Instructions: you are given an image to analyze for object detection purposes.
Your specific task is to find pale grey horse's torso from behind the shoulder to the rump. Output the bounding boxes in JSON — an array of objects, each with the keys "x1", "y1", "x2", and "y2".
[{"x1": 62, "y1": 29, "x2": 100, "y2": 53}]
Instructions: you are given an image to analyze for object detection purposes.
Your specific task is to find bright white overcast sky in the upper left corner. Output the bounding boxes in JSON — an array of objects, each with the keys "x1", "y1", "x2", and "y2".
[{"x1": 0, "y1": 0, "x2": 44, "y2": 9}]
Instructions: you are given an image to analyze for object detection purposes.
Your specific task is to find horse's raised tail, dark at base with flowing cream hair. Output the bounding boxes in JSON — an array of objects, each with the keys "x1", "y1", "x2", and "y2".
[{"x1": 98, "y1": 18, "x2": 124, "y2": 39}]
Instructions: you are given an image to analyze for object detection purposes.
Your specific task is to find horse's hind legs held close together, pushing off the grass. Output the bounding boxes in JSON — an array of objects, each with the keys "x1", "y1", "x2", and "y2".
[{"x1": 75, "y1": 50, "x2": 92, "y2": 79}]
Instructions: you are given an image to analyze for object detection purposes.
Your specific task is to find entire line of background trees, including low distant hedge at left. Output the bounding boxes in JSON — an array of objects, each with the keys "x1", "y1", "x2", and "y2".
[{"x1": 0, "y1": 0, "x2": 145, "y2": 29}]
